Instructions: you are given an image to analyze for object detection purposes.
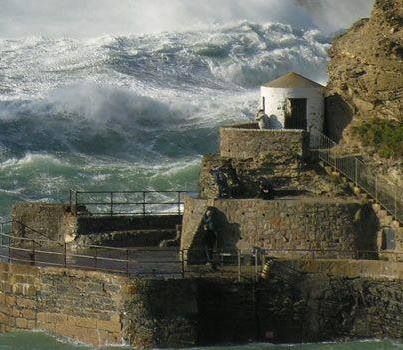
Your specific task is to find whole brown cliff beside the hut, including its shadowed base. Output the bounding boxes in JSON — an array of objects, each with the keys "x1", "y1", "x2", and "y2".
[{"x1": 327, "y1": 0, "x2": 403, "y2": 180}]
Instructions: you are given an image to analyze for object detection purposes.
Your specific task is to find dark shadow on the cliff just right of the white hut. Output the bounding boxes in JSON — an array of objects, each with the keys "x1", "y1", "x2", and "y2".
[{"x1": 325, "y1": 94, "x2": 354, "y2": 143}]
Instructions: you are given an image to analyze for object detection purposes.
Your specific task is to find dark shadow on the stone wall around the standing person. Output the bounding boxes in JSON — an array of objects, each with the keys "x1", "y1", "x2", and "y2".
[{"x1": 187, "y1": 207, "x2": 241, "y2": 264}]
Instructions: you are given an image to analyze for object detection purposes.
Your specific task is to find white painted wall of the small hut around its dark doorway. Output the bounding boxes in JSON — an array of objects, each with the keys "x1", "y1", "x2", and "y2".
[{"x1": 260, "y1": 86, "x2": 325, "y2": 131}]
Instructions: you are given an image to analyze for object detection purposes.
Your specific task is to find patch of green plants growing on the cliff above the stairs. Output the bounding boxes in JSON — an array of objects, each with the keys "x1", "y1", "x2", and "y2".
[{"x1": 354, "y1": 118, "x2": 403, "y2": 158}]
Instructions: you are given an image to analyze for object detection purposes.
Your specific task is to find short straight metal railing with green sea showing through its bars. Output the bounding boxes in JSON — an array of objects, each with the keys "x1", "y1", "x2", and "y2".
[{"x1": 70, "y1": 190, "x2": 196, "y2": 216}]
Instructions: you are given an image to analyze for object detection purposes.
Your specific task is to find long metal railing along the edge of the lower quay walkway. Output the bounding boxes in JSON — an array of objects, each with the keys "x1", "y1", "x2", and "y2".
[{"x1": 0, "y1": 230, "x2": 403, "y2": 280}]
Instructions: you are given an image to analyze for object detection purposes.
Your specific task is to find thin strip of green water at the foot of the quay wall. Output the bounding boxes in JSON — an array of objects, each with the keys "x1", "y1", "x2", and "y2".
[{"x1": 0, "y1": 333, "x2": 403, "y2": 350}]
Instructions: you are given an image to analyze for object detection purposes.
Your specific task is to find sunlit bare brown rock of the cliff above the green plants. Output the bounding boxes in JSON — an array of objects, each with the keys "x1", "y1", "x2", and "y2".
[{"x1": 329, "y1": 0, "x2": 403, "y2": 121}]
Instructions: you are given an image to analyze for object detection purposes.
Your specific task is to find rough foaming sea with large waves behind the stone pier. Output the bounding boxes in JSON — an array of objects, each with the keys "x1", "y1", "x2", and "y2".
[{"x1": 0, "y1": 21, "x2": 332, "y2": 219}]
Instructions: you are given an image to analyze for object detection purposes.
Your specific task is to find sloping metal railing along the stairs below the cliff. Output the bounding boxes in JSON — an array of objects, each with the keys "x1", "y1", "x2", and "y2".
[{"x1": 311, "y1": 129, "x2": 403, "y2": 223}]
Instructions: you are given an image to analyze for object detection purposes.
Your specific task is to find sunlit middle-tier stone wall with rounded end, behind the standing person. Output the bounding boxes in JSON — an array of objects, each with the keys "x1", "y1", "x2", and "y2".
[{"x1": 181, "y1": 197, "x2": 377, "y2": 262}]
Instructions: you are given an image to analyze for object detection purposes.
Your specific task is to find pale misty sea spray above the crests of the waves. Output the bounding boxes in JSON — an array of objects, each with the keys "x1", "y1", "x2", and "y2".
[{"x1": 0, "y1": 0, "x2": 374, "y2": 37}]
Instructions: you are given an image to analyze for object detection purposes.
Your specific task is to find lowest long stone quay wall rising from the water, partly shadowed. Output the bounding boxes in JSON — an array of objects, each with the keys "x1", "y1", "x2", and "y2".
[{"x1": 0, "y1": 260, "x2": 403, "y2": 348}]
